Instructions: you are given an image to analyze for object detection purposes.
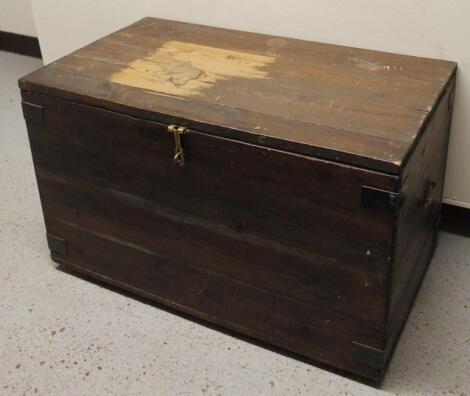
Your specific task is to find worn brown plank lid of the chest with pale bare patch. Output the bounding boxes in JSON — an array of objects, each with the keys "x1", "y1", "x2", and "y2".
[{"x1": 20, "y1": 18, "x2": 456, "y2": 174}]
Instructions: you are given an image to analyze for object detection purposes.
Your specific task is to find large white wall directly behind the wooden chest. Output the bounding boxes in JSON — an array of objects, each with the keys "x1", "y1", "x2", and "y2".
[{"x1": 31, "y1": 0, "x2": 470, "y2": 207}]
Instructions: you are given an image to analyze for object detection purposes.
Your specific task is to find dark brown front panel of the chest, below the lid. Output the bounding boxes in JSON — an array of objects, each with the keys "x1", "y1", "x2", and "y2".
[{"x1": 23, "y1": 92, "x2": 397, "y2": 378}]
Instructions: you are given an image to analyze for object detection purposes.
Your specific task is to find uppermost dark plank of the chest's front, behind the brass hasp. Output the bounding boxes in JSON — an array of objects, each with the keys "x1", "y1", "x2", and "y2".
[{"x1": 22, "y1": 91, "x2": 397, "y2": 250}]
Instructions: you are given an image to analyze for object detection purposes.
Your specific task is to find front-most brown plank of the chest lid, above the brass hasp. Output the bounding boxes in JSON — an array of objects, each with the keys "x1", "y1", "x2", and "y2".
[{"x1": 19, "y1": 69, "x2": 409, "y2": 174}]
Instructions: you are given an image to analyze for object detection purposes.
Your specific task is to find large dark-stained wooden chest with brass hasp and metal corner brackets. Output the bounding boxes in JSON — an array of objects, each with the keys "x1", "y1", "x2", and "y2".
[{"x1": 20, "y1": 18, "x2": 456, "y2": 381}]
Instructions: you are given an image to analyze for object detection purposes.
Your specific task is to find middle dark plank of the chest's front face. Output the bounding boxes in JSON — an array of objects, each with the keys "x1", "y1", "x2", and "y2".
[{"x1": 38, "y1": 170, "x2": 386, "y2": 329}]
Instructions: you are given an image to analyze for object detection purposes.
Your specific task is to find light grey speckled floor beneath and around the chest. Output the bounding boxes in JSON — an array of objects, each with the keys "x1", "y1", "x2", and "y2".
[{"x1": 0, "y1": 52, "x2": 470, "y2": 396}]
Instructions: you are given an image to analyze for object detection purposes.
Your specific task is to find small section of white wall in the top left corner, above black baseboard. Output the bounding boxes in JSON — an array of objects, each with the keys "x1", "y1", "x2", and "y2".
[{"x1": 0, "y1": 0, "x2": 36, "y2": 37}]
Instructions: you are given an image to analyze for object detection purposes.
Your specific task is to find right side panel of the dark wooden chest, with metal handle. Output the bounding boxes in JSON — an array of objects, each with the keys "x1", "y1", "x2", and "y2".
[{"x1": 387, "y1": 77, "x2": 455, "y2": 344}]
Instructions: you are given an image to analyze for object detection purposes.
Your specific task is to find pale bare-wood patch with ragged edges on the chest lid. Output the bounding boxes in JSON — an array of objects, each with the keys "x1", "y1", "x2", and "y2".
[{"x1": 109, "y1": 41, "x2": 275, "y2": 96}]
